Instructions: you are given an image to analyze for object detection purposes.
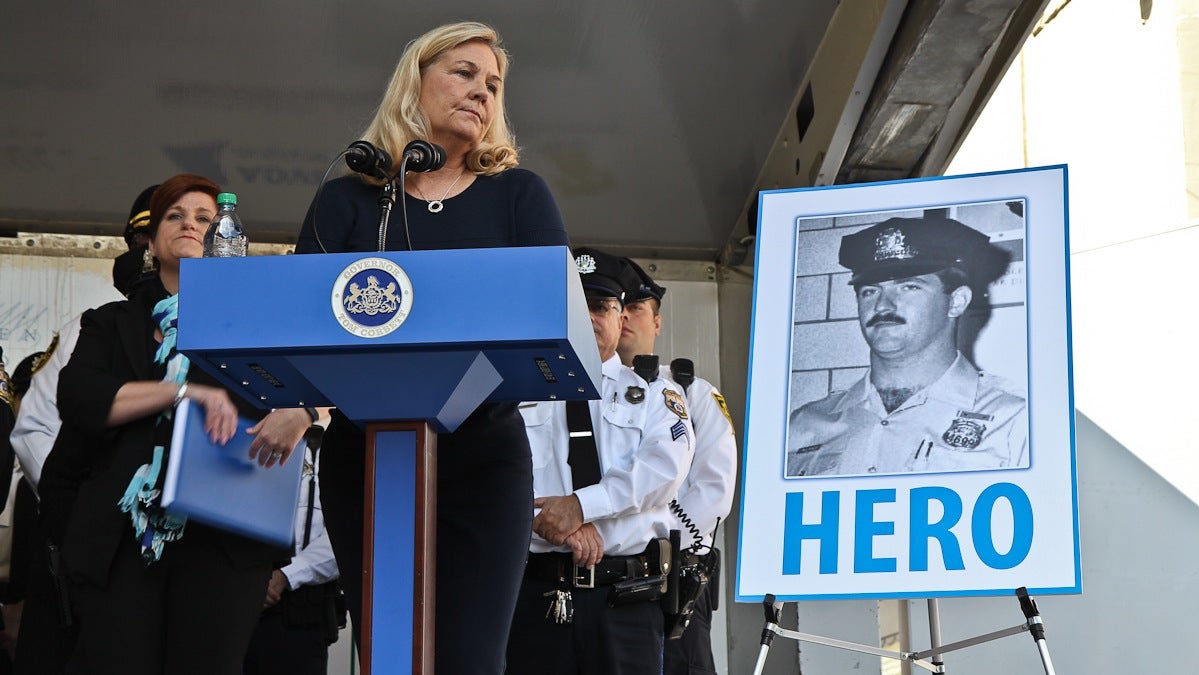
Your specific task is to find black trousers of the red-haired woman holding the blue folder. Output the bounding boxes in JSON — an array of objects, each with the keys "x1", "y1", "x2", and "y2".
[{"x1": 68, "y1": 523, "x2": 271, "y2": 675}]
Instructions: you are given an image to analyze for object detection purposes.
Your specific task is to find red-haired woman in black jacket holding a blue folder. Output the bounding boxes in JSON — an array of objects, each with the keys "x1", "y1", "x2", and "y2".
[{"x1": 40, "y1": 174, "x2": 312, "y2": 675}]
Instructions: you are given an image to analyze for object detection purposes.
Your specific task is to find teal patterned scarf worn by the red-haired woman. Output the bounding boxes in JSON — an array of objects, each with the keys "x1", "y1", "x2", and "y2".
[{"x1": 118, "y1": 294, "x2": 191, "y2": 565}]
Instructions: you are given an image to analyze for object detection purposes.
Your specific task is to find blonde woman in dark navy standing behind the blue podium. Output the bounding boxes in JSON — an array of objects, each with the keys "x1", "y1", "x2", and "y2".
[{"x1": 296, "y1": 23, "x2": 568, "y2": 674}]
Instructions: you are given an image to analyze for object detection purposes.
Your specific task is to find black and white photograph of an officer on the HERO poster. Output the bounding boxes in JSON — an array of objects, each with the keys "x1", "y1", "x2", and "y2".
[{"x1": 784, "y1": 199, "x2": 1030, "y2": 478}]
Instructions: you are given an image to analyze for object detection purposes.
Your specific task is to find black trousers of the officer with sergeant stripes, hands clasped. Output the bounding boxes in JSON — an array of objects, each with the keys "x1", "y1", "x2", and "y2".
[{"x1": 507, "y1": 579, "x2": 663, "y2": 675}]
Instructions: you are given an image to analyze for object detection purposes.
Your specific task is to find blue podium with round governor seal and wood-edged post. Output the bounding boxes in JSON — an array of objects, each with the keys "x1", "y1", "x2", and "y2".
[{"x1": 179, "y1": 247, "x2": 600, "y2": 674}]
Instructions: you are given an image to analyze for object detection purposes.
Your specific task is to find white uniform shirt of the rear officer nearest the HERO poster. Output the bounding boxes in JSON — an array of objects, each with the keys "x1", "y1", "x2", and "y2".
[{"x1": 658, "y1": 366, "x2": 737, "y2": 548}]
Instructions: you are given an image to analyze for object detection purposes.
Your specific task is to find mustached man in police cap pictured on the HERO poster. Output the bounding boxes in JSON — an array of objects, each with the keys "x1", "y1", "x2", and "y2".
[{"x1": 787, "y1": 216, "x2": 1029, "y2": 477}]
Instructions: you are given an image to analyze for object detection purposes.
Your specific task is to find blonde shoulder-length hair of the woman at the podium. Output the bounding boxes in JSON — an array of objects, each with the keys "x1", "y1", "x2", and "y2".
[{"x1": 362, "y1": 22, "x2": 519, "y2": 182}]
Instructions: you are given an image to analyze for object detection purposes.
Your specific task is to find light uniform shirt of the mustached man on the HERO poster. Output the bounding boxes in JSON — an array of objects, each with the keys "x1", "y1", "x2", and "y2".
[{"x1": 787, "y1": 354, "x2": 1029, "y2": 476}]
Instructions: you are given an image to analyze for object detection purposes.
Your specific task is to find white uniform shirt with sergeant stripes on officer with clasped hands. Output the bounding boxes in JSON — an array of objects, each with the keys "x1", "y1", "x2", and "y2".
[{"x1": 520, "y1": 356, "x2": 694, "y2": 555}]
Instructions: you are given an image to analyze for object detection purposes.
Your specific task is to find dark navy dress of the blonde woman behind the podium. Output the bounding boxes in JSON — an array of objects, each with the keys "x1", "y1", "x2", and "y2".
[{"x1": 296, "y1": 169, "x2": 568, "y2": 675}]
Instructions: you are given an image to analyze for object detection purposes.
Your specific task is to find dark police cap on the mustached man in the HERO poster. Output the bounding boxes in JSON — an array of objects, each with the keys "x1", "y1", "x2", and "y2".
[{"x1": 838, "y1": 216, "x2": 1010, "y2": 285}]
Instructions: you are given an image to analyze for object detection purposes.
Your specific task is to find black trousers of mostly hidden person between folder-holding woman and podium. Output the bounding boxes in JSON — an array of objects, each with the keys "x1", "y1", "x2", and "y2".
[{"x1": 243, "y1": 609, "x2": 329, "y2": 675}]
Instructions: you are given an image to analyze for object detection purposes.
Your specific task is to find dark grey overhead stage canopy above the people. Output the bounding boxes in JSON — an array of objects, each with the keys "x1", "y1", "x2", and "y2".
[{"x1": 0, "y1": 0, "x2": 1044, "y2": 260}]
